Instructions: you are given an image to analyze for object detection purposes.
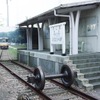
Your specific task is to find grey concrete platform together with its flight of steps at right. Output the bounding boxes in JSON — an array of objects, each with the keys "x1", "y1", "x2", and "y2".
[{"x1": 18, "y1": 50, "x2": 100, "y2": 90}]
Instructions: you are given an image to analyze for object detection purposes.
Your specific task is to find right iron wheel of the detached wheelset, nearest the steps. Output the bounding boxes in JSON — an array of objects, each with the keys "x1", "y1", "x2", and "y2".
[{"x1": 61, "y1": 65, "x2": 74, "y2": 87}]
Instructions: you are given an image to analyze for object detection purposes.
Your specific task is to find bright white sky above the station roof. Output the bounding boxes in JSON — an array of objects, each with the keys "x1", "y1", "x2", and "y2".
[{"x1": 0, "y1": 0, "x2": 88, "y2": 26}]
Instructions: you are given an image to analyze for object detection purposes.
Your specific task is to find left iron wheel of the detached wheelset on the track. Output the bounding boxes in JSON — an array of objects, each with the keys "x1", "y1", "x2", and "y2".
[{"x1": 34, "y1": 67, "x2": 45, "y2": 90}]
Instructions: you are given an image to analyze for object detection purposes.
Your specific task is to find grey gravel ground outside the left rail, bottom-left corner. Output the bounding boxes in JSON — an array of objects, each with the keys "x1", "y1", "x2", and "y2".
[{"x1": 0, "y1": 67, "x2": 26, "y2": 100}]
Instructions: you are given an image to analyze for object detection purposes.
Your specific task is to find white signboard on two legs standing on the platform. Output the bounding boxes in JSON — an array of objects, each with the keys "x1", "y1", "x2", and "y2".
[{"x1": 49, "y1": 22, "x2": 66, "y2": 53}]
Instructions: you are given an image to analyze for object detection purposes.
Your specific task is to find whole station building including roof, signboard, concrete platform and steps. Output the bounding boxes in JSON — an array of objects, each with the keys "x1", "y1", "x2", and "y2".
[{"x1": 18, "y1": 0, "x2": 100, "y2": 89}]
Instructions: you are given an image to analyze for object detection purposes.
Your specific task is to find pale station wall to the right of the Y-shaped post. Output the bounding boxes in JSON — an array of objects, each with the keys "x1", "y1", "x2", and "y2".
[{"x1": 79, "y1": 7, "x2": 100, "y2": 52}]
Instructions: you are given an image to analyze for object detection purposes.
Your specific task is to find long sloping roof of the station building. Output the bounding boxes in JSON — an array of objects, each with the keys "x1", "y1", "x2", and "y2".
[{"x1": 18, "y1": 0, "x2": 100, "y2": 26}]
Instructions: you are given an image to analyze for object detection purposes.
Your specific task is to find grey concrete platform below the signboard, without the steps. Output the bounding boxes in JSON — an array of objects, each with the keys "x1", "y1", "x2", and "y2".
[{"x1": 18, "y1": 50, "x2": 69, "y2": 74}]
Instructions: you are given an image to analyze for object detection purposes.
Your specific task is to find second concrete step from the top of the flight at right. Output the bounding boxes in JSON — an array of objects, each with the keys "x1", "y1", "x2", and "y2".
[{"x1": 73, "y1": 58, "x2": 100, "y2": 64}]
